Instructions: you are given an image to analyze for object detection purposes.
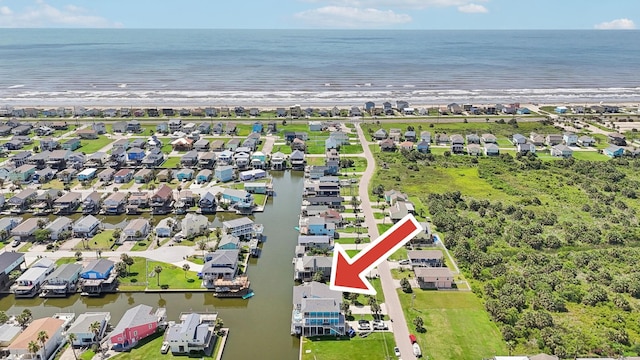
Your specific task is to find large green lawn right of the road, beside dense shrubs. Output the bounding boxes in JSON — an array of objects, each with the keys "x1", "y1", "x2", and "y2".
[{"x1": 398, "y1": 289, "x2": 508, "y2": 360}]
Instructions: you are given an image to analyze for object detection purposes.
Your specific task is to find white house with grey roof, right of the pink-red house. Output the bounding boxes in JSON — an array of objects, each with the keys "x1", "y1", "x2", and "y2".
[{"x1": 165, "y1": 313, "x2": 216, "y2": 355}]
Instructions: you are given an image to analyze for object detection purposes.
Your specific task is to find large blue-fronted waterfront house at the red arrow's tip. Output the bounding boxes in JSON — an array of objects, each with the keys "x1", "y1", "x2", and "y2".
[{"x1": 291, "y1": 281, "x2": 347, "y2": 336}]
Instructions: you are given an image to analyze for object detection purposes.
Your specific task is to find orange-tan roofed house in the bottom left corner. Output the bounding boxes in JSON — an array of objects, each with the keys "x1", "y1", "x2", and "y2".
[{"x1": 7, "y1": 317, "x2": 65, "y2": 359}]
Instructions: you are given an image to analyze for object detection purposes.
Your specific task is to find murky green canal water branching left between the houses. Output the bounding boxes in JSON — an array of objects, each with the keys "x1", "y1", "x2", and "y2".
[{"x1": 0, "y1": 171, "x2": 303, "y2": 360}]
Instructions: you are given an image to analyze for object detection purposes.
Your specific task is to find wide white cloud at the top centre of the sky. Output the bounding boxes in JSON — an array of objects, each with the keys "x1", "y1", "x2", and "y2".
[{"x1": 294, "y1": 6, "x2": 412, "y2": 28}]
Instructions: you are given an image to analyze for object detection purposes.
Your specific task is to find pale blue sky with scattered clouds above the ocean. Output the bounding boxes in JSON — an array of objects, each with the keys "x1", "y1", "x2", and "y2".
[{"x1": 0, "y1": 0, "x2": 640, "y2": 30}]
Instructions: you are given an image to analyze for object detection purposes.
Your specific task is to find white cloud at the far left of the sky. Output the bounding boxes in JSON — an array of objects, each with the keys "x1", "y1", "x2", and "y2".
[{"x1": 0, "y1": 0, "x2": 122, "y2": 28}]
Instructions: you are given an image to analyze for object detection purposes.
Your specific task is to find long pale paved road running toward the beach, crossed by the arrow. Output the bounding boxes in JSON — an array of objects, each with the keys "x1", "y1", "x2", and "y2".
[{"x1": 356, "y1": 124, "x2": 416, "y2": 360}]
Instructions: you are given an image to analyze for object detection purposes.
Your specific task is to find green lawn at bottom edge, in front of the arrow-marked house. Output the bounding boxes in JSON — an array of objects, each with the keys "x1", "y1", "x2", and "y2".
[{"x1": 302, "y1": 332, "x2": 395, "y2": 360}]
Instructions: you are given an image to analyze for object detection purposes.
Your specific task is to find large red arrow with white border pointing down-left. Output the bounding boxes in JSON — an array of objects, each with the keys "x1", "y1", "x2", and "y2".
[{"x1": 329, "y1": 215, "x2": 422, "y2": 295}]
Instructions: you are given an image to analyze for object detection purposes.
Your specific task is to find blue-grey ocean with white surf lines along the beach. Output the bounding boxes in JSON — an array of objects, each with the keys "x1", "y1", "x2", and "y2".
[{"x1": 0, "y1": 29, "x2": 640, "y2": 106}]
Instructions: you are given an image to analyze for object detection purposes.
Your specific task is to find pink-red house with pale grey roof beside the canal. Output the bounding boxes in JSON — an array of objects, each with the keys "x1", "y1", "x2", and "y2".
[{"x1": 109, "y1": 304, "x2": 166, "y2": 351}]
